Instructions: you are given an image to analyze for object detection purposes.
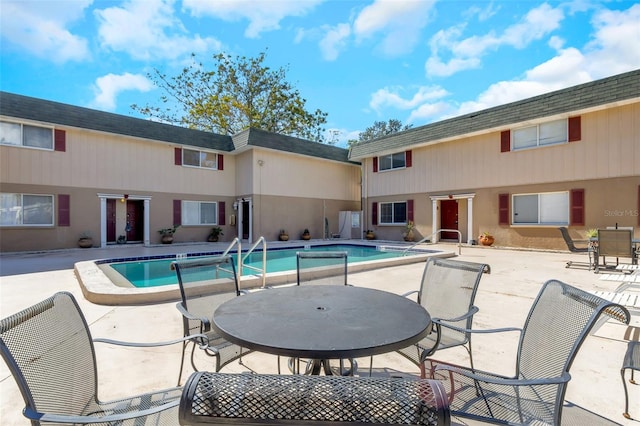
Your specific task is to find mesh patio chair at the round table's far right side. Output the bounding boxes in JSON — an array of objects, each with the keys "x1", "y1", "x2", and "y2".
[{"x1": 398, "y1": 258, "x2": 491, "y2": 367}]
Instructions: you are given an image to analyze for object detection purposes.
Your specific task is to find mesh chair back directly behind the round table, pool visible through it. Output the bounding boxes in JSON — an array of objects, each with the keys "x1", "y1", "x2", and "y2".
[{"x1": 296, "y1": 251, "x2": 348, "y2": 285}]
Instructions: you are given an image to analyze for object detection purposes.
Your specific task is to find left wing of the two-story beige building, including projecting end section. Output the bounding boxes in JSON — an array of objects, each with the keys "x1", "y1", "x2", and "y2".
[{"x1": 0, "y1": 92, "x2": 360, "y2": 252}]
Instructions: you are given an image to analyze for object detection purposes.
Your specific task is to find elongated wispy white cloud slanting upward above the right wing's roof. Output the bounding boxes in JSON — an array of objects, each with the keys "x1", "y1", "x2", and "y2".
[{"x1": 425, "y1": 3, "x2": 564, "y2": 76}]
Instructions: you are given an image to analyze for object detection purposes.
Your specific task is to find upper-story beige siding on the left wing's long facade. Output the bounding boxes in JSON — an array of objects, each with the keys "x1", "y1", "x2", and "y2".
[{"x1": 0, "y1": 129, "x2": 235, "y2": 196}]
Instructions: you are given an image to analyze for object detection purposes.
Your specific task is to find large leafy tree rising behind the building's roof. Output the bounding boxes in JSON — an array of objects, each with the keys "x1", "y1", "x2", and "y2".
[{"x1": 131, "y1": 52, "x2": 327, "y2": 142}]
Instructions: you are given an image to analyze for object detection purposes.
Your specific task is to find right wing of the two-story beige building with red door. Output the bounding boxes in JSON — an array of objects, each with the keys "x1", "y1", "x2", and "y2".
[{"x1": 349, "y1": 70, "x2": 640, "y2": 249}]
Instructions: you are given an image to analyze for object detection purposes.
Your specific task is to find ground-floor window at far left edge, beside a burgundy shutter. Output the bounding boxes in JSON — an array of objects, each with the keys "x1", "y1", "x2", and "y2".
[{"x1": 0, "y1": 193, "x2": 53, "y2": 226}]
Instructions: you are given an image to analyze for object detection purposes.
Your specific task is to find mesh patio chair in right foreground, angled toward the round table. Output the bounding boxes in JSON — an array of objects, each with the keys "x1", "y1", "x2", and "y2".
[{"x1": 427, "y1": 280, "x2": 630, "y2": 425}]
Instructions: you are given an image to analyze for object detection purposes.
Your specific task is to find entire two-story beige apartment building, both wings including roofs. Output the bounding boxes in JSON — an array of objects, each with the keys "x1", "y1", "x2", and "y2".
[{"x1": 0, "y1": 70, "x2": 640, "y2": 252}]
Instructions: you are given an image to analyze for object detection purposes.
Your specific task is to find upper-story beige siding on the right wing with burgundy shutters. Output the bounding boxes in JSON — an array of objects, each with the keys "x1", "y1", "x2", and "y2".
[{"x1": 366, "y1": 103, "x2": 640, "y2": 197}]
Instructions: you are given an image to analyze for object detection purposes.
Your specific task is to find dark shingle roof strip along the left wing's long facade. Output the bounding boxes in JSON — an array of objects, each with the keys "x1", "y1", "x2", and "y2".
[{"x1": 0, "y1": 92, "x2": 233, "y2": 152}]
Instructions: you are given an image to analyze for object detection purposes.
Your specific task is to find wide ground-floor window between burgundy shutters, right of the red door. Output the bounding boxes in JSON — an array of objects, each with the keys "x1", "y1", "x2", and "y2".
[{"x1": 512, "y1": 192, "x2": 569, "y2": 225}]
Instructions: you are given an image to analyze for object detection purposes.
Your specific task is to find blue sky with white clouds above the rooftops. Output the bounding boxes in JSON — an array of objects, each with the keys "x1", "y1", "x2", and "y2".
[{"x1": 0, "y1": 0, "x2": 640, "y2": 145}]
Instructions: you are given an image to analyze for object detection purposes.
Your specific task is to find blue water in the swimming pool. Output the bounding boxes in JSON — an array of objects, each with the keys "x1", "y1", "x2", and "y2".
[{"x1": 108, "y1": 244, "x2": 429, "y2": 287}]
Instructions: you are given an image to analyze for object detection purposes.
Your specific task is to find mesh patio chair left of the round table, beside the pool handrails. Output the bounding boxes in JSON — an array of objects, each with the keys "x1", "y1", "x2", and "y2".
[{"x1": 171, "y1": 255, "x2": 249, "y2": 380}]
